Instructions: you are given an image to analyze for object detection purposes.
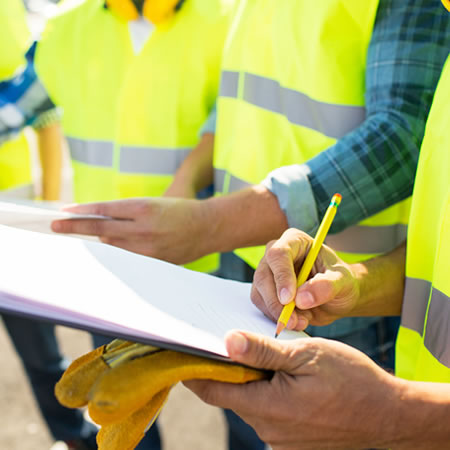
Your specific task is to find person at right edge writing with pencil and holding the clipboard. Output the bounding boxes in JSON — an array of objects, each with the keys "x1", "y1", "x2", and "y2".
[{"x1": 185, "y1": 37, "x2": 450, "y2": 450}]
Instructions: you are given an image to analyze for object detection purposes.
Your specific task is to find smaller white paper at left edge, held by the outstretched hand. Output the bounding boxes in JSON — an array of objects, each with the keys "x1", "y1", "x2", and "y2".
[{"x1": 0, "y1": 198, "x2": 110, "y2": 233}]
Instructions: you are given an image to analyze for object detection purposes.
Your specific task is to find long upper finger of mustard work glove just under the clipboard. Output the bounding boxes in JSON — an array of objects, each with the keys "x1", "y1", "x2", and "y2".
[{"x1": 89, "y1": 350, "x2": 267, "y2": 425}]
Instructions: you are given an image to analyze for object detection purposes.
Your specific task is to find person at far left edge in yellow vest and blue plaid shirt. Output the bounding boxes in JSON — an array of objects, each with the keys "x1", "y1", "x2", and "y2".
[{"x1": 0, "y1": 0, "x2": 97, "y2": 450}]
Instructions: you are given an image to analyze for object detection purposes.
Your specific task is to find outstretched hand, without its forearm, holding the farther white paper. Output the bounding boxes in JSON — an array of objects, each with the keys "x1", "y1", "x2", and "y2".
[{"x1": 52, "y1": 198, "x2": 214, "y2": 264}]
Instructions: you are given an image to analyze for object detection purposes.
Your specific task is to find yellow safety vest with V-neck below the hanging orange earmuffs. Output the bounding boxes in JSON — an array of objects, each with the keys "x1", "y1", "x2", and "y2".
[{"x1": 37, "y1": 0, "x2": 234, "y2": 272}]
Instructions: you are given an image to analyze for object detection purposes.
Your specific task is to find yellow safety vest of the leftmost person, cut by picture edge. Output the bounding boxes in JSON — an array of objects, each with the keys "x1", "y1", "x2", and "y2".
[{"x1": 0, "y1": 0, "x2": 34, "y2": 198}]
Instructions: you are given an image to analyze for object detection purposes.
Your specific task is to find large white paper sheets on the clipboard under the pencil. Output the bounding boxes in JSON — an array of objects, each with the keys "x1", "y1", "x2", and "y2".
[{"x1": 0, "y1": 226, "x2": 305, "y2": 356}]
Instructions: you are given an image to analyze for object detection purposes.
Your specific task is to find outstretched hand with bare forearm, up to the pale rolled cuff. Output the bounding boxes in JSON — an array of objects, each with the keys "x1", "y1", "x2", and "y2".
[{"x1": 52, "y1": 185, "x2": 287, "y2": 264}]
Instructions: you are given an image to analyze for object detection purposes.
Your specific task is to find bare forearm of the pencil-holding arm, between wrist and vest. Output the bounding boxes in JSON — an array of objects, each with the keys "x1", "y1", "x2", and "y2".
[{"x1": 349, "y1": 244, "x2": 406, "y2": 316}]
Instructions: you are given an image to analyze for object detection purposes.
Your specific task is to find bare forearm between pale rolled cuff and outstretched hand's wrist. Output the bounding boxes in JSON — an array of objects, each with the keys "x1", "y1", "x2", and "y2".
[{"x1": 203, "y1": 185, "x2": 288, "y2": 254}]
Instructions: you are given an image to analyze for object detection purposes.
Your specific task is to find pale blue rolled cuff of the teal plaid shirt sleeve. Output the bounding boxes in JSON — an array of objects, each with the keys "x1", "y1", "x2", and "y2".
[{"x1": 261, "y1": 164, "x2": 319, "y2": 235}]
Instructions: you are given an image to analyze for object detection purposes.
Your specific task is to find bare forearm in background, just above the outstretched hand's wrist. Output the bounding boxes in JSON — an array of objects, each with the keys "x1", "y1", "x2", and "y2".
[{"x1": 165, "y1": 133, "x2": 214, "y2": 197}]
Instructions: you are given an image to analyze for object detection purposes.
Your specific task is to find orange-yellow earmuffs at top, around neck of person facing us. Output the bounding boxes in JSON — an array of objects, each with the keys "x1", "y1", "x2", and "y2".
[{"x1": 106, "y1": 0, "x2": 180, "y2": 25}]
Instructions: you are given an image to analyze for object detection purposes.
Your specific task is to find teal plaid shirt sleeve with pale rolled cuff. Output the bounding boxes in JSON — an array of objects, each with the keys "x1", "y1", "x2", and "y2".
[{"x1": 263, "y1": 0, "x2": 450, "y2": 233}]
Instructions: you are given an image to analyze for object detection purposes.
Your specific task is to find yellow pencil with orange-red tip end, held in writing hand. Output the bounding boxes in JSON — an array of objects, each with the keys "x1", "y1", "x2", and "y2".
[{"x1": 275, "y1": 194, "x2": 342, "y2": 338}]
